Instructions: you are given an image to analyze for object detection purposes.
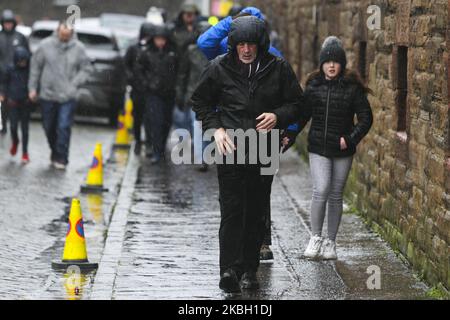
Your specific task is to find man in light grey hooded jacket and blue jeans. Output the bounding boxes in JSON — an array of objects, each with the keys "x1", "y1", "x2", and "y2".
[{"x1": 28, "y1": 22, "x2": 91, "y2": 170}]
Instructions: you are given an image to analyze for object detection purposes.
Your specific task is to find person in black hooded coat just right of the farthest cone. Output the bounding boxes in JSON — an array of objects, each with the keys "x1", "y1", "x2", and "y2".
[{"x1": 137, "y1": 26, "x2": 178, "y2": 164}]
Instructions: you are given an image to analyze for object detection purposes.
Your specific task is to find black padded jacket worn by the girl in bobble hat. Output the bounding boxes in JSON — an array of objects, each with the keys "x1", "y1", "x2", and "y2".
[{"x1": 299, "y1": 70, "x2": 373, "y2": 157}]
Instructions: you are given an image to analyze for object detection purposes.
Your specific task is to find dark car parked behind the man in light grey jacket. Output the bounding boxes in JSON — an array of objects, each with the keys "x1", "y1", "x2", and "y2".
[{"x1": 30, "y1": 18, "x2": 126, "y2": 125}]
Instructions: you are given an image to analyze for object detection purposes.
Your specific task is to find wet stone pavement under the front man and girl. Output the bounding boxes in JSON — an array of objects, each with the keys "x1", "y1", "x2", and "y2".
[{"x1": 89, "y1": 148, "x2": 428, "y2": 300}]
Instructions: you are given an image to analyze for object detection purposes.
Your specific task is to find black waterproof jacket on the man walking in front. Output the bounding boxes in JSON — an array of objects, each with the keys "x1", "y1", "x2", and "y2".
[{"x1": 191, "y1": 53, "x2": 303, "y2": 130}]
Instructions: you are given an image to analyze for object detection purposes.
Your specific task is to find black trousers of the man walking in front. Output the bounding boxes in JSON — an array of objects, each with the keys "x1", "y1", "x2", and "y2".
[{"x1": 217, "y1": 164, "x2": 273, "y2": 276}]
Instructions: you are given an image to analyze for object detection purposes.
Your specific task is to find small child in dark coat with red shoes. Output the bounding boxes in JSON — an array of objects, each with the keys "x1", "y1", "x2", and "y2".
[{"x1": 0, "y1": 47, "x2": 30, "y2": 164}]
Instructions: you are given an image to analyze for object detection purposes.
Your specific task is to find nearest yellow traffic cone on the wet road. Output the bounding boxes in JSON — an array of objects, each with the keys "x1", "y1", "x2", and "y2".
[{"x1": 52, "y1": 199, "x2": 98, "y2": 271}]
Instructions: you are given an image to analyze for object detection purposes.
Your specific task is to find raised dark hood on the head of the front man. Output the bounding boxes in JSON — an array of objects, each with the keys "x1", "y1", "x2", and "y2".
[{"x1": 228, "y1": 16, "x2": 270, "y2": 52}]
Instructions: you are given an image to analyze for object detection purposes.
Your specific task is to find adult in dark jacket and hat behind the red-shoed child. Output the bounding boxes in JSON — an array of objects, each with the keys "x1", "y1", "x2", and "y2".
[{"x1": 0, "y1": 10, "x2": 30, "y2": 134}]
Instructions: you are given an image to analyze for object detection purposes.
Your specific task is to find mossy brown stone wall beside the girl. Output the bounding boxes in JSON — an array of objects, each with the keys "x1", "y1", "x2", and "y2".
[{"x1": 247, "y1": 0, "x2": 450, "y2": 289}]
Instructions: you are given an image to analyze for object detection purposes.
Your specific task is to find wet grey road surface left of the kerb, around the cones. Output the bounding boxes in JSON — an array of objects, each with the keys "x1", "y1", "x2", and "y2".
[{"x1": 0, "y1": 122, "x2": 127, "y2": 299}]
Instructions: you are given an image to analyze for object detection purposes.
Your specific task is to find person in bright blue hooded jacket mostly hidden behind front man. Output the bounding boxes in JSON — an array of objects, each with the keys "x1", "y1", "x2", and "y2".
[{"x1": 197, "y1": 7, "x2": 288, "y2": 260}]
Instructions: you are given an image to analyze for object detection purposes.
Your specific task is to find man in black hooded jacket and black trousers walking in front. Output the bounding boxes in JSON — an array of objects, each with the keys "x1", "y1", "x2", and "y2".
[{"x1": 191, "y1": 16, "x2": 302, "y2": 292}]
